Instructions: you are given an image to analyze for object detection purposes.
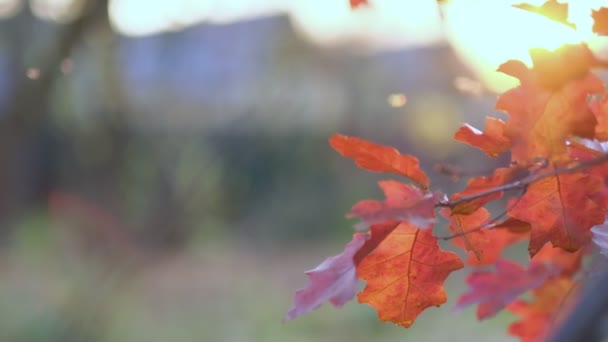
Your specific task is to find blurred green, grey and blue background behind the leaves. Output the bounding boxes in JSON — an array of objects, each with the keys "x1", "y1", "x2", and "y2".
[{"x1": 0, "y1": 0, "x2": 600, "y2": 342}]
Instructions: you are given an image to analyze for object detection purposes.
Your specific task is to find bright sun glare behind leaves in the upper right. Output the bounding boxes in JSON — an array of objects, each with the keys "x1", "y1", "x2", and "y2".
[{"x1": 444, "y1": 0, "x2": 597, "y2": 92}]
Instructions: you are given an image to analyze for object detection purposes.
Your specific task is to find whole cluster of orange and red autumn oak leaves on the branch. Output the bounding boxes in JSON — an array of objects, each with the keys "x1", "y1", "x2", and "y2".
[{"x1": 286, "y1": 0, "x2": 608, "y2": 341}]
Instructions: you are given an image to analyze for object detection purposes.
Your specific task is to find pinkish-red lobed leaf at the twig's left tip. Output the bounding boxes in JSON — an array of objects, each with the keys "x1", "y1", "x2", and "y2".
[{"x1": 346, "y1": 180, "x2": 437, "y2": 229}]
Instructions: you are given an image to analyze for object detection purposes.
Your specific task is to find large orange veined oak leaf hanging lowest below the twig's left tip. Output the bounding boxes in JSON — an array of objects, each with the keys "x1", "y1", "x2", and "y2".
[{"x1": 357, "y1": 223, "x2": 464, "y2": 327}]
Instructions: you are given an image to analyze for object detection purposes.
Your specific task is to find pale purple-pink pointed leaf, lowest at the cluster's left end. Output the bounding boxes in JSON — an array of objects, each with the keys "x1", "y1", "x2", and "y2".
[{"x1": 285, "y1": 233, "x2": 369, "y2": 320}]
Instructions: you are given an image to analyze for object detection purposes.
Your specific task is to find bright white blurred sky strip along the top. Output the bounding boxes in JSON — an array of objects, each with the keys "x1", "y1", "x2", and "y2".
[{"x1": 0, "y1": 0, "x2": 606, "y2": 92}]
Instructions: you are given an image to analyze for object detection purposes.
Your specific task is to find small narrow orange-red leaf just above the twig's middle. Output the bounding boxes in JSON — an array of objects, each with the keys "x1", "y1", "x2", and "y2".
[{"x1": 450, "y1": 166, "x2": 529, "y2": 214}]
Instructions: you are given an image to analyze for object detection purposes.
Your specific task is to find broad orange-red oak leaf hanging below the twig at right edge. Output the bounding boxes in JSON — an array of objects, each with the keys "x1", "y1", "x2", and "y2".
[{"x1": 509, "y1": 172, "x2": 606, "y2": 256}]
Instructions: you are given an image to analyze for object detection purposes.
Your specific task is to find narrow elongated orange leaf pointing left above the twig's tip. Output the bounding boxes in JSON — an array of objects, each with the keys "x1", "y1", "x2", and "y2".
[{"x1": 329, "y1": 134, "x2": 429, "y2": 189}]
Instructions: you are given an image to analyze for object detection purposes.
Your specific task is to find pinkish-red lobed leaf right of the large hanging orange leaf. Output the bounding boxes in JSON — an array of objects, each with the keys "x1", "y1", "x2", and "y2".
[{"x1": 454, "y1": 259, "x2": 559, "y2": 320}]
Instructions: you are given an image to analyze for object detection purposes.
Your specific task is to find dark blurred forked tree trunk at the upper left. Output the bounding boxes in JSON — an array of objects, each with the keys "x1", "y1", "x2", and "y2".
[{"x1": 0, "y1": 0, "x2": 108, "y2": 241}]
